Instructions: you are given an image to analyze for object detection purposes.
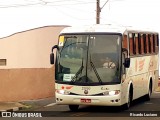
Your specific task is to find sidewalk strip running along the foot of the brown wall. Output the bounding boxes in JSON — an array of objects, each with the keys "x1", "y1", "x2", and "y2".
[{"x1": 0, "y1": 97, "x2": 55, "y2": 112}]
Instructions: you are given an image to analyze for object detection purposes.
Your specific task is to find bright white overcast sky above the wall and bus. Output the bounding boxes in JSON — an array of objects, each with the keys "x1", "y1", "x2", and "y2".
[{"x1": 0, "y1": 0, "x2": 160, "y2": 38}]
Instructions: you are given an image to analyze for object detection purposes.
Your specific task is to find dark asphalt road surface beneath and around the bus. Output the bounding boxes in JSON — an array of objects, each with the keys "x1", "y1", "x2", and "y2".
[{"x1": 31, "y1": 93, "x2": 160, "y2": 119}]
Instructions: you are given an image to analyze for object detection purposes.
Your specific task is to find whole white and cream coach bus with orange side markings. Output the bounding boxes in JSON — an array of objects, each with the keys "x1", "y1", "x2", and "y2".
[{"x1": 50, "y1": 25, "x2": 159, "y2": 111}]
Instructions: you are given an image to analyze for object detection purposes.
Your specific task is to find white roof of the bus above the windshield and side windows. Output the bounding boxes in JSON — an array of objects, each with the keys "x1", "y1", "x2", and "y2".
[{"x1": 61, "y1": 24, "x2": 158, "y2": 34}]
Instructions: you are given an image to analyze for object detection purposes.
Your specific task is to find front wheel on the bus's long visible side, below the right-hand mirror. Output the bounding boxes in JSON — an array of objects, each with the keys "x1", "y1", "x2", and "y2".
[{"x1": 123, "y1": 86, "x2": 133, "y2": 110}]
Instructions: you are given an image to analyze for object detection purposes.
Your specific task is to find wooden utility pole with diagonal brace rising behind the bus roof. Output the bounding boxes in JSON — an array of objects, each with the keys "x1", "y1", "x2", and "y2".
[{"x1": 96, "y1": 0, "x2": 109, "y2": 24}]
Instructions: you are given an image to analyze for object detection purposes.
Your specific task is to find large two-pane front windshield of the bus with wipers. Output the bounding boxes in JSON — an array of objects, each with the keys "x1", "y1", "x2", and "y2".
[{"x1": 55, "y1": 34, "x2": 121, "y2": 85}]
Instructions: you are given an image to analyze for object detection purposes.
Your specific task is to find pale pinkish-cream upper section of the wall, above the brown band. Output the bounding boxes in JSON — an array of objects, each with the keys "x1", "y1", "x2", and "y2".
[{"x1": 0, "y1": 26, "x2": 65, "y2": 69}]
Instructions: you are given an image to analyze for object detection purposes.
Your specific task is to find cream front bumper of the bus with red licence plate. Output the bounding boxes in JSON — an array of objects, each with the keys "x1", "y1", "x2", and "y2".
[{"x1": 56, "y1": 93, "x2": 121, "y2": 106}]
